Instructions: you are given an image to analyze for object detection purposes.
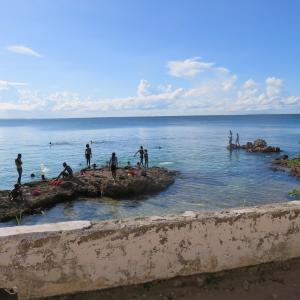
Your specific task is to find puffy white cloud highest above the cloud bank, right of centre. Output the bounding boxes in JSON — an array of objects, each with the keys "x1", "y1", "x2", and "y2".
[{"x1": 167, "y1": 57, "x2": 214, "y2": 77}]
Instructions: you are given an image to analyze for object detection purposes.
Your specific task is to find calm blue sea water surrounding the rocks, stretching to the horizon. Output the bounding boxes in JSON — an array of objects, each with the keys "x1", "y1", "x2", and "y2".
[{"x1": 0, "y1": 115, "x2": 300, "y2": 226}]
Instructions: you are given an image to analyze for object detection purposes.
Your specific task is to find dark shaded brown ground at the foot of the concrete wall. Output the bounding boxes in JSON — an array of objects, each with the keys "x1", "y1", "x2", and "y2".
[{"x1": 44, "y1": 258, "x2": 300, "y2": 300}]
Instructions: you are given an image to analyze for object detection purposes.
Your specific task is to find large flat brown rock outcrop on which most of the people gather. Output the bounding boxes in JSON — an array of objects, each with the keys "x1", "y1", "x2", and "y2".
[{"x1": 0, "y1": 168, "x2": 177, "y2": 221}]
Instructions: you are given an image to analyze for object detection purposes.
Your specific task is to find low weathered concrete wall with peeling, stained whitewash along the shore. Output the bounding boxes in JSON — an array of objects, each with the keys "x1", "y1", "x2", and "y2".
[{"x1": 0, "y1": 201, "x2": 300, "y2": 299}]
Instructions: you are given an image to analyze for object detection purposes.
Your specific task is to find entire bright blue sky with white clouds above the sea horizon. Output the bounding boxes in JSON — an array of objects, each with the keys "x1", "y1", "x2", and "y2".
[{"x1": 0, "y1": 0, "x2": 300, "y2": 118}]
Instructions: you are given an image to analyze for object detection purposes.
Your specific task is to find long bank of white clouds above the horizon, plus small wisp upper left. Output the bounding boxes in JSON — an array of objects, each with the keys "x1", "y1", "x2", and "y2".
[{"x1": 0, "y1": 56, "x2": 300, "y2": 118}]
